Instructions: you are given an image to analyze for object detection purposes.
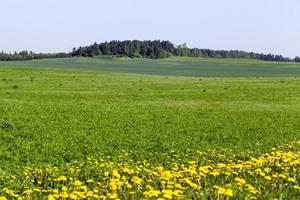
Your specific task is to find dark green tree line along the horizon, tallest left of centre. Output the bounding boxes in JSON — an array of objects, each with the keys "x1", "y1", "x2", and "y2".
[{"x1": 0, "y1": 40, "x2": 300, "y2": 62}]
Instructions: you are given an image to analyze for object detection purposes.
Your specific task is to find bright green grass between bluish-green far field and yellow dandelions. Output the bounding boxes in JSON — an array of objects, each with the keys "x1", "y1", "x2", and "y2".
[{"x1": 0, "y1": 66, "x2": 300, "y2": 171}]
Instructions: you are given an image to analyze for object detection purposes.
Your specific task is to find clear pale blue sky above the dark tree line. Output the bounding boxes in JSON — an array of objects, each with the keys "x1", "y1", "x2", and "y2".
[{"x1": 0, "y1": 0, "x2": 300, "y2": 57}]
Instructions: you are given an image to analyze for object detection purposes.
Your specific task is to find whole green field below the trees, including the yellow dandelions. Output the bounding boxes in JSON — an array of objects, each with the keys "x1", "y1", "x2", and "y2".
[{"x1": 0, "y1": 58, "x2": 300, "y2": 199}]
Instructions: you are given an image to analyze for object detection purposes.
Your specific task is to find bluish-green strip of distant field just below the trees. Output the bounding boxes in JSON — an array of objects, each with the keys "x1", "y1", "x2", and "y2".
[{"x1": 0, "y1": 57, "x2": 300, "y2": 77}]
